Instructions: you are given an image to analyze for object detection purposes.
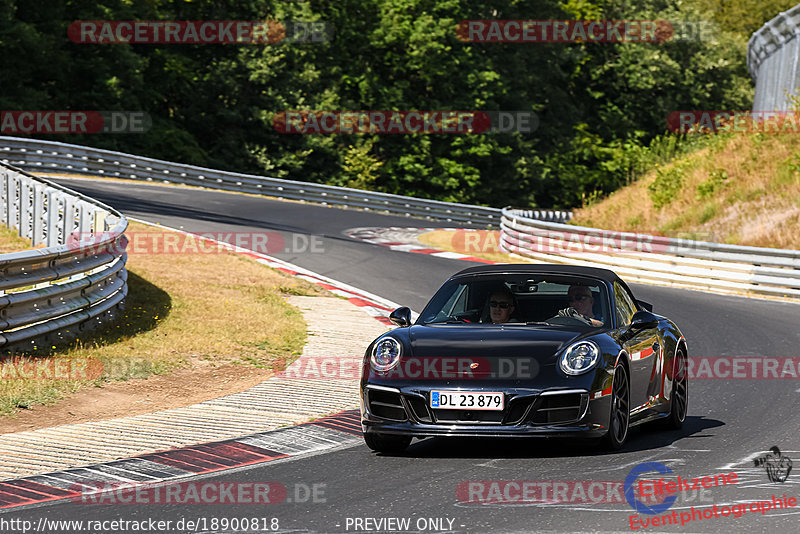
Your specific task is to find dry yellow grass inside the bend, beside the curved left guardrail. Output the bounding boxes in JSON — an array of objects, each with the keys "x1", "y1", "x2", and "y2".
[{"x1": 0, "y1": 223, "x2": 325, "y2": 414}]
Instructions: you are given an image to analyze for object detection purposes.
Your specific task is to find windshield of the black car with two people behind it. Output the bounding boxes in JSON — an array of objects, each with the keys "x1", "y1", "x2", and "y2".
[{"x1": 418, "y1": 274, "x2": 611, "y2": 327}]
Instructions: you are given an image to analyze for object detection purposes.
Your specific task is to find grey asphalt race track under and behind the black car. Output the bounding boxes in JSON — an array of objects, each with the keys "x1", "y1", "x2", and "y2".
[{"x1": 0, "y1": 180, "x2": 800, "y2": 532}]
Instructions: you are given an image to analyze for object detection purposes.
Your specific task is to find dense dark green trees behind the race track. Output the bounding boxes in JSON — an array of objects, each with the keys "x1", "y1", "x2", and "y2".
[{"x1": 0, "y1": 0, "x2": 785, "y2": 208}]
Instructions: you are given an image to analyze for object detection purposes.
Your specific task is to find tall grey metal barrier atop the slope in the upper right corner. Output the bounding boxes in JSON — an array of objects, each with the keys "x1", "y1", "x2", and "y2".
[{"x1": 747, "y1": 5, "x2": 800, "y2": 111}]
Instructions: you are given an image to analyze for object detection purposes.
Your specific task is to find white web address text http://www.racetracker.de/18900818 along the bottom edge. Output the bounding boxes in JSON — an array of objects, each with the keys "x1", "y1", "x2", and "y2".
[{"x1": 0, "y1": 516, "x2": 280, "y2": 534}]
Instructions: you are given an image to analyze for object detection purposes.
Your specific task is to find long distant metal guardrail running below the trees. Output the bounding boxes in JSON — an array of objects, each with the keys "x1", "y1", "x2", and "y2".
[{"x1": 0, "y1": 137, "x2": 572, "y2": 227}]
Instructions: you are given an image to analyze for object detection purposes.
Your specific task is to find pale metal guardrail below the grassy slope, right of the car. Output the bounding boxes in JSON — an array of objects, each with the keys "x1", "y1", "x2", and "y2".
[{"x1": 500, "y1": 208, "x2": 800, "y2": 298}]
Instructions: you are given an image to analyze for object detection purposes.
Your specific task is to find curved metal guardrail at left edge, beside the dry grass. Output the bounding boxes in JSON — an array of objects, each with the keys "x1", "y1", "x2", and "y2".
[{"x1": 0, "y1": 165, "x2": 128, "y2": 351}]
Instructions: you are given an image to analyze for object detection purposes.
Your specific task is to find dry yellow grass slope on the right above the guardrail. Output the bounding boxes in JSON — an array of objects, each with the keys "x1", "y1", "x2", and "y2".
[{"x1": 571, "y1": 134, "x2": 800, "y2": 249}]
